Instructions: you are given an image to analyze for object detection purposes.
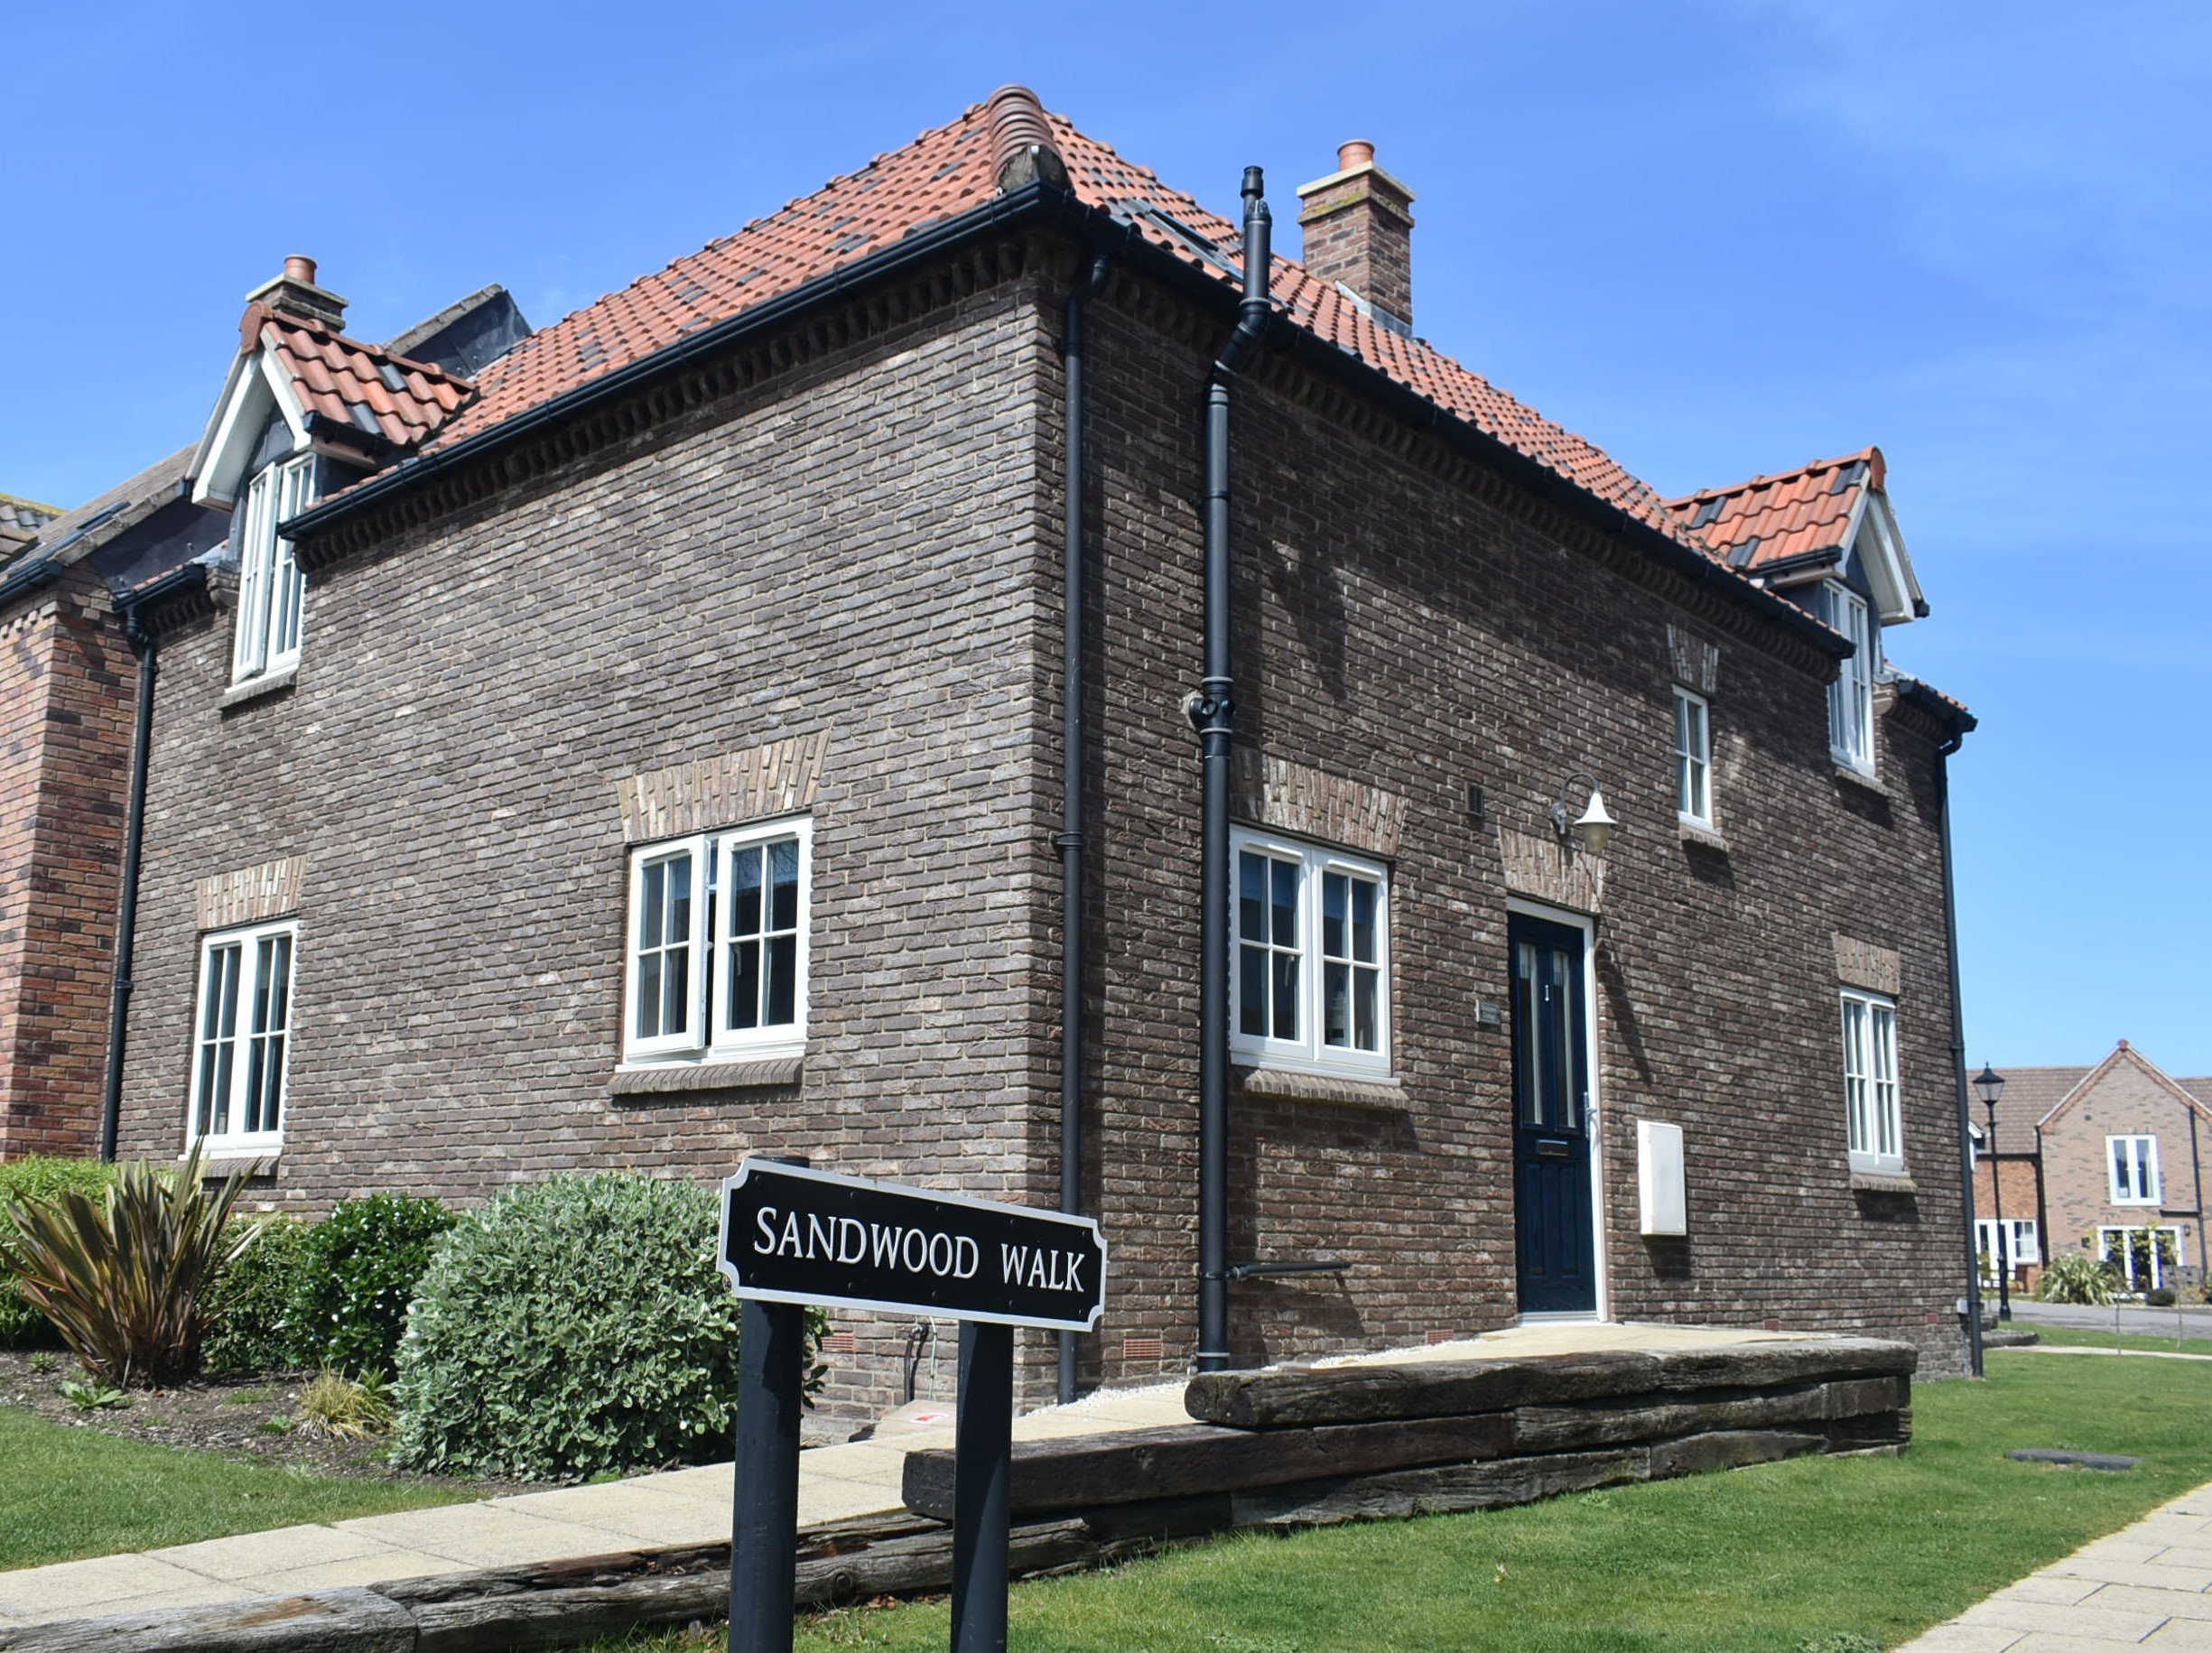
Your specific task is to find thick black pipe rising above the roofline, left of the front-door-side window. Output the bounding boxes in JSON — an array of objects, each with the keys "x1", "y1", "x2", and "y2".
[{"x1": 1184, "y1": 166, "x2": 1272, "y2": 1372}]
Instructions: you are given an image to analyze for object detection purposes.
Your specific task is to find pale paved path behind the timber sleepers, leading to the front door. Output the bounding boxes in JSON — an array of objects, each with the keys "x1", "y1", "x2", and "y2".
[{"x1": 0, "y1": 1323, "x2": 1794, "y2": 1627}]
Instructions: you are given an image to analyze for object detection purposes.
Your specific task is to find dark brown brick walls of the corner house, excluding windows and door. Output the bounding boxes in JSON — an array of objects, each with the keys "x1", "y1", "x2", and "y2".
[{"x1": 126, "y1": 236, "x2": 1960, "y2": 1409}]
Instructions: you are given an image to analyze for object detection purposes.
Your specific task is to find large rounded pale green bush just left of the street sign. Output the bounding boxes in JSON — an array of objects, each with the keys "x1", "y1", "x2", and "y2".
[{"x1": 392, "y1": 1173, "x2": 800, "y2": 1481}]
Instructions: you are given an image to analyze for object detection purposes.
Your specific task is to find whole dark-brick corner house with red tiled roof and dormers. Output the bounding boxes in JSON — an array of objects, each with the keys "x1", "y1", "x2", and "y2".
[{"x1": 90, "y1": 88, "x2": 1973, "y2": 1409}]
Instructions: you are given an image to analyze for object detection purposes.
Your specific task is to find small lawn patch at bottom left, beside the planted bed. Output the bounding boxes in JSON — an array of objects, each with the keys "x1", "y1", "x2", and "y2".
[{"x1": 0, "y1": 1407, "x2": 476, "y2": 1569}]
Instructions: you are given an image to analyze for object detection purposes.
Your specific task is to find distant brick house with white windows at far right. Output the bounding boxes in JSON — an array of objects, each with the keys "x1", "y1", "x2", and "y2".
[{"x1": 1973, "y1": 1040, "x2": 2212, "y2": 1290}]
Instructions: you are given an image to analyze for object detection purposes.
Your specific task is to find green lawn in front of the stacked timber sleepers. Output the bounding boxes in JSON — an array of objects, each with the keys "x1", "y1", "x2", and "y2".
[{"x1": 597, "y1": 1352, "x2": 2212, "y2": 1653}]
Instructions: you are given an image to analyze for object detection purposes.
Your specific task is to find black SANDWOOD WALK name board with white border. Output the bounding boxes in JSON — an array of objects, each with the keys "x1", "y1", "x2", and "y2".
[{"x1": 719, "y1": 1157, "x2": 1106, "y2": 1333}]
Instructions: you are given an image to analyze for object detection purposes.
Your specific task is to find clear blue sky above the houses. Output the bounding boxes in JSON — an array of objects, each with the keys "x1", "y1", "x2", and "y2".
[{"x1": 13, "y1": 0, "x2": 2212, "y2": 1073}]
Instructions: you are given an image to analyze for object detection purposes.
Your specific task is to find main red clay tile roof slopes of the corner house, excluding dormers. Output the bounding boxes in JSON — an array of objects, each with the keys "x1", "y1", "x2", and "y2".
[{"x1": 436, "y1": 104, "x2": 1710, "y2": 553}]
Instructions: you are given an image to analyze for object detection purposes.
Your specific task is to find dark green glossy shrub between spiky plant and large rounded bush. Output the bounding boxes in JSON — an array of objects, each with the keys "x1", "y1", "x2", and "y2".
[{"x1": 292, "y1": 1193, "x2": 458, "y2": 1379}]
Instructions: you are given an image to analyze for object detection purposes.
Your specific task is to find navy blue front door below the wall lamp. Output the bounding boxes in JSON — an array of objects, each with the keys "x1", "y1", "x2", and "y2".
[{"x1": 1506, "y1": 914, "x2": 1597, "y2": 1314}]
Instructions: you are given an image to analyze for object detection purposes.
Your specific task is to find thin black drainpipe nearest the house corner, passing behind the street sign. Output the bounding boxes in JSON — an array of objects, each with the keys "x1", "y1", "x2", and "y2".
[{"x1": 1053, "y1": 255, "x2": 1106, "y2": 1405}]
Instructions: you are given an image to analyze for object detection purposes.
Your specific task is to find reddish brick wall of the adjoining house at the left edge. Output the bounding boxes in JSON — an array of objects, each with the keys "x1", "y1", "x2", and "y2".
[{"x1": 0, "y1": 569, "x2": 137, "y2": 1159}]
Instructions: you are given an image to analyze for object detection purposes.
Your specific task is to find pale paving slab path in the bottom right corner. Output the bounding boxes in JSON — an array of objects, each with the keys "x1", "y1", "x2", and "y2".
[{"x1": 1904, "y1": 1482, "x2": 2212, "y2": 1653}]
